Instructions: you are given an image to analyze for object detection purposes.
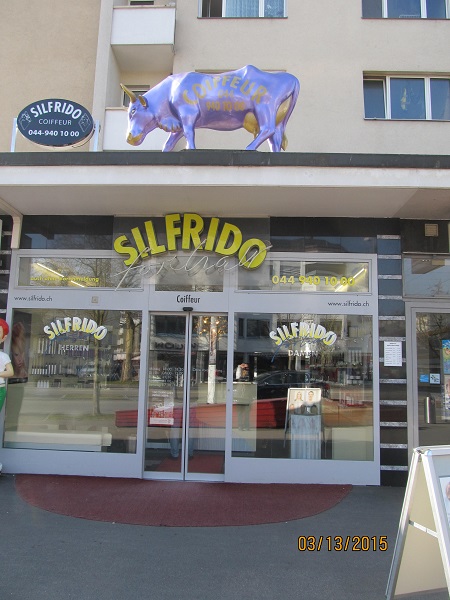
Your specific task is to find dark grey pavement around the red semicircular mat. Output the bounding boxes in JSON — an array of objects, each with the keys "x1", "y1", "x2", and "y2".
[{"x1": 0, "y1": 475, "x2": 448, "y2": 600}]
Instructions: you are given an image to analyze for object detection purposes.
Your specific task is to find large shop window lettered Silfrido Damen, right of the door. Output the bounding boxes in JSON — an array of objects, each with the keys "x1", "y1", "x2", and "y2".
[{"x1": 233, "y1": 313, "x2": 374, "y2": 461}]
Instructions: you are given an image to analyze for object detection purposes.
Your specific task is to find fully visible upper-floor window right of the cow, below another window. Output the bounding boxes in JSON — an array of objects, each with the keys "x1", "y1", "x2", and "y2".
[{"x1": 364, "y1": 76, "x2": 450, "y2": 121}]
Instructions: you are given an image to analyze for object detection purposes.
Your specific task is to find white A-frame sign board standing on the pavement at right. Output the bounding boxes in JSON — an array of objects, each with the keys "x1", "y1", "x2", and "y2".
[{"x1": 386, "y1": 446, "x2": 450, "y2": 600}]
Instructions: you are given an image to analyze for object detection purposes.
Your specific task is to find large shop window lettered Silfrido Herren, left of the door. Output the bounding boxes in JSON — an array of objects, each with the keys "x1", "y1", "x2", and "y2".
[{"x1": 3, "y1": 309, "x2": 142, "y2": 453}]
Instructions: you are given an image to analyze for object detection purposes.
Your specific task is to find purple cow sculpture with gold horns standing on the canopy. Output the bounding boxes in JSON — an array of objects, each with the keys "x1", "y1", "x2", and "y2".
[{"x1": 121, "y1": 65, "x2": 300, "y2": 152}]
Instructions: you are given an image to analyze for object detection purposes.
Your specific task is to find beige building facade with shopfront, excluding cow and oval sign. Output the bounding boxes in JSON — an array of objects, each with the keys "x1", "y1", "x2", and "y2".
[{"x1": 0, "y1": 0, "x2": 450, "y2": 484}]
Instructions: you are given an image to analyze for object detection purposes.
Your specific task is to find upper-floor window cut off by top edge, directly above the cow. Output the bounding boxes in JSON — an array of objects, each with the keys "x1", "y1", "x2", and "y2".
[{"x1": 201, "y1": 0, "x2": 285, "y2": 18}]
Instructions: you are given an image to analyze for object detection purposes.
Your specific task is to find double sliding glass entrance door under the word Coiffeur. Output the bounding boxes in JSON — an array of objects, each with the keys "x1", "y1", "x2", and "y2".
[{"x1": 145, "y1": 312, "x2": 227, "y2": 481}]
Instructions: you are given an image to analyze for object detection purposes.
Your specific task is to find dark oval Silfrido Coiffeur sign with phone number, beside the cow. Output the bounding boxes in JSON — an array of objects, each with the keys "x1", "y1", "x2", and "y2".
[{"x1": 17, "y1": 99, "x2": 94, "y2": 147}]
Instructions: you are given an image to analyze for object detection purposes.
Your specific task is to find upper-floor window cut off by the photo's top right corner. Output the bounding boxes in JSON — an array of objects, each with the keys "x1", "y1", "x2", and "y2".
[{"x1": 362, "y1": 0, "x2": 449, "y2": 19}]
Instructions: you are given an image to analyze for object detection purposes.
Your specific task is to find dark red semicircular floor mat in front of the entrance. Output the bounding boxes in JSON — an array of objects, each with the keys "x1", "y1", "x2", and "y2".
[{"x1": 16, "y1": 475, "x2": 352, "y2": 527}]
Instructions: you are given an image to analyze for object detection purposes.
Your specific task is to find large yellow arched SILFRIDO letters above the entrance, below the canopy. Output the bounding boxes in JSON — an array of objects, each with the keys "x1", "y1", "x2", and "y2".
[{"x1": 114, "y1": 213, "x2": 270, "y2": 269}]
